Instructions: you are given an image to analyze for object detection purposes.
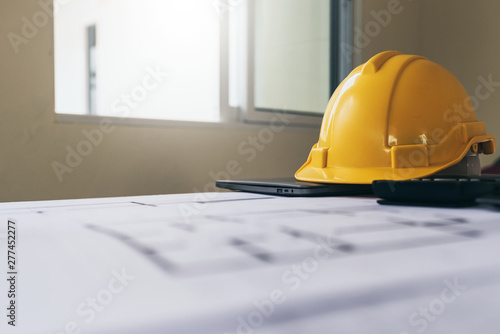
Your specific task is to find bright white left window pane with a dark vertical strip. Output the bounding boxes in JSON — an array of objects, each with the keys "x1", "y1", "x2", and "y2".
[{"x1": 54, "y1": 0, "x2": 219, "y2": 121}]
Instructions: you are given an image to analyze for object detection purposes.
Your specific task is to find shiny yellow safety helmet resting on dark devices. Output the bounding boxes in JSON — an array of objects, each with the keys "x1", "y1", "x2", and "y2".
[{"x1": 295, "y1": 51, "x2": 495, "y2": 183}]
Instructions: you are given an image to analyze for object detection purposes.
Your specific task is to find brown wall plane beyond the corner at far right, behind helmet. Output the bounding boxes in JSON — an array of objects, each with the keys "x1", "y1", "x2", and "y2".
[{"x1": 420, "y1": 0, "x2": 500, "y2": 165}]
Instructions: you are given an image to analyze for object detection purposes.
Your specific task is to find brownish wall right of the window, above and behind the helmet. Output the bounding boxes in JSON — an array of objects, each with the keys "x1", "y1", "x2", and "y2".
[{"x1": 357, "y1": 0, "x2": 500, "y2": 165}]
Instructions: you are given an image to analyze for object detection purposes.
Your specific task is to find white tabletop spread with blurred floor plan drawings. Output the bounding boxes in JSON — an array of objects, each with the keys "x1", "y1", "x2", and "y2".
[{"x1": 0, "y1": 193, "x2": 500, "y2": 334}]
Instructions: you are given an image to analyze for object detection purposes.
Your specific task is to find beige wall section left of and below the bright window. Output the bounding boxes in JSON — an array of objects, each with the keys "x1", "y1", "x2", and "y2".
[{"x1": 0, "y1": 0, "x2": 318, "y2": 201}]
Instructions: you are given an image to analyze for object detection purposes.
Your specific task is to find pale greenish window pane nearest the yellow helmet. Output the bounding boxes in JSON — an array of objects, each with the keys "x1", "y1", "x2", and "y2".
[{"x1": 254, "y1": 0, "x2": 331, "y2": 113}]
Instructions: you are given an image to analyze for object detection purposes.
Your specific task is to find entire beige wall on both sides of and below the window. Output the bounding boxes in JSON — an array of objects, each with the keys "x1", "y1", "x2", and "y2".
[{"x1": 0, "y1": 0, "x2": 500, "y2": 201}]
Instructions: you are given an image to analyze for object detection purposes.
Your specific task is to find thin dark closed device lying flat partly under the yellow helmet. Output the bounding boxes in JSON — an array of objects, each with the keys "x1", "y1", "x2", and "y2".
[{"x1": 215, "y1": 178, "x2": 373, "y2": 197}]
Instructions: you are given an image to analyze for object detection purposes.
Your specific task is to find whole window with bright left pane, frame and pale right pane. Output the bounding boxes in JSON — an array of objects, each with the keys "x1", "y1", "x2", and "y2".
[{"x1": 54, "y1": 0, "x2": 351, "y2": 124}]
